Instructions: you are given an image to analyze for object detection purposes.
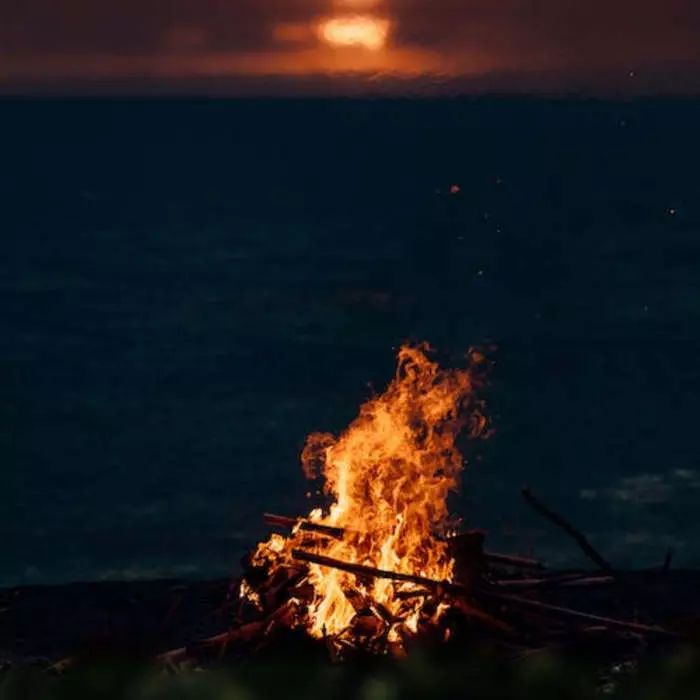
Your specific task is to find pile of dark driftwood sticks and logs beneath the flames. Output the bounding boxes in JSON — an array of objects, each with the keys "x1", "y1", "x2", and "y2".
[{"x1": 139, "y1": 490, "x2": 684, "y2": 668}]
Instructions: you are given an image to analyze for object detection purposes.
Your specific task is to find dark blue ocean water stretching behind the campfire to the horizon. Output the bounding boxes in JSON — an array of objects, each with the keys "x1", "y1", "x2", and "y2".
[{"x1": 0, "y1": 99, "x2": 700, "y2": 585}]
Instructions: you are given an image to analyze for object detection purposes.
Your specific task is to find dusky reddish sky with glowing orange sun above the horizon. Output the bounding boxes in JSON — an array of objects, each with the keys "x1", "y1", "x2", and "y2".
[{"x1": 0, "y1": 0, "x2": 700, "y2": 95}]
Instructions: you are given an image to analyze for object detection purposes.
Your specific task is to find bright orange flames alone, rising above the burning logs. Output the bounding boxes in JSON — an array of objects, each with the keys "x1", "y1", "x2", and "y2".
[{"x1": 253, "y1": 344, "x2": 486, "y2": 640}]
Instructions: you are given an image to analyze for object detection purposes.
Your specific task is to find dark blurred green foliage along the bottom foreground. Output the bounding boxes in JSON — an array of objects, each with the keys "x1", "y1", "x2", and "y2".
[{"x1": 0, "y1": 650, "x2": 700, "y2": 700}]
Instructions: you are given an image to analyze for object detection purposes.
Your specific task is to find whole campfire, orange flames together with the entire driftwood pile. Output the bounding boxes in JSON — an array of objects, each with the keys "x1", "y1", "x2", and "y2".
[{"x1": 213, "y1": 345, "x2": 684, "y2": 660}]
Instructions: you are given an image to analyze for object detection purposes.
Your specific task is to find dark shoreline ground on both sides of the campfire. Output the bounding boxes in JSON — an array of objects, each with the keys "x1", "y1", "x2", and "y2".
[{"x1": 0, "y1": 570, "x2": 700, "y2": 664}]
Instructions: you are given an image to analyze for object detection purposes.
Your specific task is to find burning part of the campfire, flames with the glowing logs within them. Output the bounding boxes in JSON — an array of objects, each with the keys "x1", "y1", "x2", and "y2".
[{"x1": 242, "y1": 346, "x2": 486, "y2": 652}]
